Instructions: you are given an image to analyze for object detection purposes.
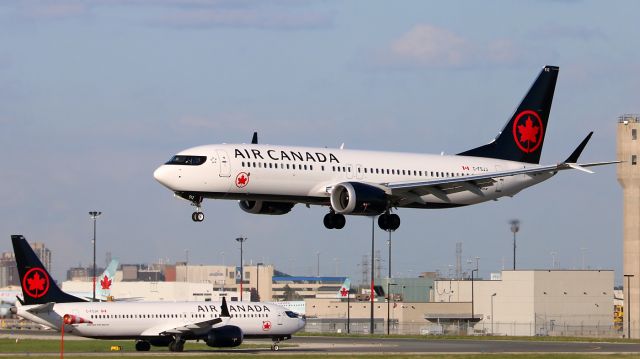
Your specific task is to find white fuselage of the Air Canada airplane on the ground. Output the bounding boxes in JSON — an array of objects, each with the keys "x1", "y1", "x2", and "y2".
[{"x1": 17, "y1": 302, "x2": 305, "y2": 339}]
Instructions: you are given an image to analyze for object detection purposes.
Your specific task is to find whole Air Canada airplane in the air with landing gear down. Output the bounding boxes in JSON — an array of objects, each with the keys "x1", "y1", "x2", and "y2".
[{"x1": 153, "y1": 66, "x2": 617, "y2": 230}]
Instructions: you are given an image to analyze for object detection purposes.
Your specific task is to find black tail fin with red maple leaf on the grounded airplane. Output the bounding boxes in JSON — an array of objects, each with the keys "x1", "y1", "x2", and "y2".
[{"x1": 11, "y1": 235, "x2": 85, "y2": 305}]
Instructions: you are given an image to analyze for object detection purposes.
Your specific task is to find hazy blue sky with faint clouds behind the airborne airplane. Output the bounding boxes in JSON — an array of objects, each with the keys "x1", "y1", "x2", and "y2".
[{"x1": 0, "y1": 0, "x2": 640, "y2": 282}]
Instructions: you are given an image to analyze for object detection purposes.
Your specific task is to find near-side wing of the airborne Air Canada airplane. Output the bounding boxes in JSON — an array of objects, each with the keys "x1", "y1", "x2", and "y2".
[{"x1": 382, "y1": 161, "x2": 620, "y2": 204}]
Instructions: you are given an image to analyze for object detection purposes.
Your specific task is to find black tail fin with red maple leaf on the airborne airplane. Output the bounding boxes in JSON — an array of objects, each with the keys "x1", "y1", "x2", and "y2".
[{"x1": 458, "y1": 66, "x2": 560, "y2": 163}]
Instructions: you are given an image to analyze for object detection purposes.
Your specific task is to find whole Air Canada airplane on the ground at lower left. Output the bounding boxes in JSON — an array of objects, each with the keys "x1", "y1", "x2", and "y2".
[{"x1": 11, "y1": 235, "x2": 305, "y2": 352}]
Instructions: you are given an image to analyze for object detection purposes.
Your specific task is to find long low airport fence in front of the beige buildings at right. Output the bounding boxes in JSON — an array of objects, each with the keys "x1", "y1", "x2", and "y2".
[{"x1": 304, "y1": 318, "x2": 624, "y2": 338}]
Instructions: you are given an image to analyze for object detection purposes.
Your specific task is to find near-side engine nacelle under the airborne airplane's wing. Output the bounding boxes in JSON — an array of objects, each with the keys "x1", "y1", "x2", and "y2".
[{"x1": 331, "y1": 182, "x2": 387, "y2": 215}]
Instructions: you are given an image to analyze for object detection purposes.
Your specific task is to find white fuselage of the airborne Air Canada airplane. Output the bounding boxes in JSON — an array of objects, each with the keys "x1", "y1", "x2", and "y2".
[{"x1": 154, "y1": 144, "x2": 553, "y2": 208}]
